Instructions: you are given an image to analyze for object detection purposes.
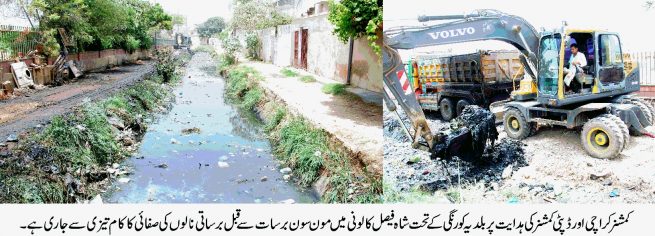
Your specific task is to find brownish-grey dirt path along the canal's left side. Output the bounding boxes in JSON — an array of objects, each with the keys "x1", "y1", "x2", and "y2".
[{"x1": 0, "y1": 62, "x2": 154, "y2": 142}]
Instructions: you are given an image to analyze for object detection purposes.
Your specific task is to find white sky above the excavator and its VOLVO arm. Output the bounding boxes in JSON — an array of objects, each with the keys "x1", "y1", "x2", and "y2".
[{"x1": 384, "y1": 0, "x2": 655, "y2": 58}]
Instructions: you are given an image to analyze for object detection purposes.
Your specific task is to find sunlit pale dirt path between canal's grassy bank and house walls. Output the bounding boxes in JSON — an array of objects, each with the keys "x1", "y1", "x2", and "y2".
[{"x1": 243, "y1": 62, "x2": 382, "y2": 176}]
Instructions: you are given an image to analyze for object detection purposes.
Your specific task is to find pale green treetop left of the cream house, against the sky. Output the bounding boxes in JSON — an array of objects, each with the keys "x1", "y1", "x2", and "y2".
[{"x1": 230, "y1": 0, "x2": 291, "y2": 30}]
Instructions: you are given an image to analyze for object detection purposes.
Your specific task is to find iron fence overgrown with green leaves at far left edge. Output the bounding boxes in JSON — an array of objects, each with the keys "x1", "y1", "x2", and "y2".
[{"x1": 0, "y1": 25, "x2": 41, "y2": 61}]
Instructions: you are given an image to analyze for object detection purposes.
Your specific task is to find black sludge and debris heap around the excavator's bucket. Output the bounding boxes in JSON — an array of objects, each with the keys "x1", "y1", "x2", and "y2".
[{"x1": 384, "y1": 106, "x2": 528, "y2": 194}]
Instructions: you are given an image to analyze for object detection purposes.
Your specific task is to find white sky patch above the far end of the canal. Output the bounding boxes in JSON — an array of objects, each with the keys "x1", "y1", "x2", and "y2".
[{"x1": 152, "y1": 0, "x2": 232, "y2": 28}]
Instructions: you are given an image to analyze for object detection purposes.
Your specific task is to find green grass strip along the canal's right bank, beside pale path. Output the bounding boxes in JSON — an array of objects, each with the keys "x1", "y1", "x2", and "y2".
[{"x1": 226, "y1": 66, "x2": 382, "y2": 203}]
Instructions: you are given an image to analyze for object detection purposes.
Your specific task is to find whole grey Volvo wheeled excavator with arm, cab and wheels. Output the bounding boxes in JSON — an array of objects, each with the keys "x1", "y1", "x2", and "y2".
[{"x1": 382, "y1": 9, "x2": 655, "y2": 159}]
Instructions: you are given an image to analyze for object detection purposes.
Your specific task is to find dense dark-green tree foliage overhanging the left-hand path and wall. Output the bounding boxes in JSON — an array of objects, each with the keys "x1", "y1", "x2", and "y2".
[{"x1": 31, "y1": 0, "x2": 172, "y2": 51}]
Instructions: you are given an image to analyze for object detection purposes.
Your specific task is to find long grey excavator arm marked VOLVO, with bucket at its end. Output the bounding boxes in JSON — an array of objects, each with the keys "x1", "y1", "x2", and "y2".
[{"x1": 382, "y1": 10, "x2": 540, "y2": 158}]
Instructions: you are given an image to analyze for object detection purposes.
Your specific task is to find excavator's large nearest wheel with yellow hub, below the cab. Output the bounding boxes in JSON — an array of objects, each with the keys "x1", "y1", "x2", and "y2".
[{"x1": 580, "y1": 116, "x2": 625, "y2": 159}]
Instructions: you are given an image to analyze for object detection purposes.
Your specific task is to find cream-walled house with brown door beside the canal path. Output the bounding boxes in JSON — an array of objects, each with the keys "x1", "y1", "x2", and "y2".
[{"x1": 258, "y1": 0, "x2": 382, "y2": 92}]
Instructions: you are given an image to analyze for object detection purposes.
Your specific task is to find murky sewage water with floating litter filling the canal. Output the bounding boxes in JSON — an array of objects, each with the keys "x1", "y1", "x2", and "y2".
[{"x1": 104, "y1": 53, "x2": 318, "y2": 203}]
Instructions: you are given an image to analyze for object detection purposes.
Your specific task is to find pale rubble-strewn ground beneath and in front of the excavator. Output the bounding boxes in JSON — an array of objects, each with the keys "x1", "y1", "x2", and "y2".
[{"x1": 384, "y1": 103, "x2": 655, "y2": 203}]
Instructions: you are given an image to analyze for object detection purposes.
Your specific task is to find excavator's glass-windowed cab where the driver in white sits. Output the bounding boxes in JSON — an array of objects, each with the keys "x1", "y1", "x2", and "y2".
[{"x1": 536, "y1": 29, "x2": 639, "y2": 107}]
